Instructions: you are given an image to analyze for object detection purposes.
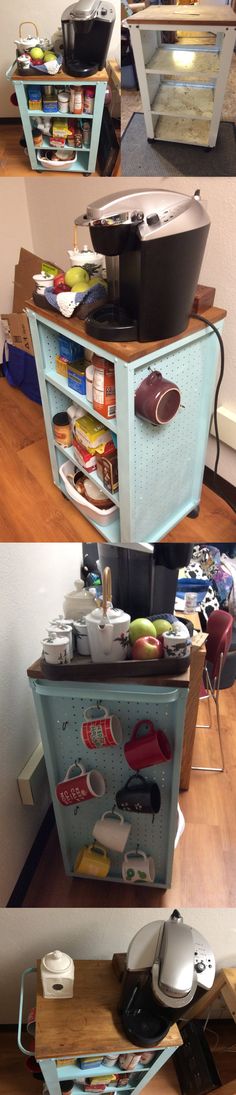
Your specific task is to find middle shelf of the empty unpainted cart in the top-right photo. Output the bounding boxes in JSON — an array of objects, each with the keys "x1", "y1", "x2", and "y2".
[{"x1": 151, "y1": 83, "x2": 214, "y2": 122}]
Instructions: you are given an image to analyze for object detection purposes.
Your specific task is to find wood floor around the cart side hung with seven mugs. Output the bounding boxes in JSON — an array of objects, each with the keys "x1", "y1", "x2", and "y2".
[{"x1": 23, "y1": 683, "x2": 236, "y2": 909}]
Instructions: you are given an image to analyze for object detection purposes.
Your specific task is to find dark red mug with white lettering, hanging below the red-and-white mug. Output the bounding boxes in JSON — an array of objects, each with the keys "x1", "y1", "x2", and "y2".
[{"x1": 56, "y1": 763, "x2": 106, "y2": 806}]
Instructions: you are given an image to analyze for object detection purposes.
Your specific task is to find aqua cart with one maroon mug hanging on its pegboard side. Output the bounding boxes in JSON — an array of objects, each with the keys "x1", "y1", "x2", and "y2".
[{"x1": 27, "y1": 301, "x2": 226, "y2": 543}]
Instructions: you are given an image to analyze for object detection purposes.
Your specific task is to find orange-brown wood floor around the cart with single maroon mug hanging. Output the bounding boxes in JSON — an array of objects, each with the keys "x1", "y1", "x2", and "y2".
[{"x1": 0, "y1": 379, "x2": 236, "y2": 543}]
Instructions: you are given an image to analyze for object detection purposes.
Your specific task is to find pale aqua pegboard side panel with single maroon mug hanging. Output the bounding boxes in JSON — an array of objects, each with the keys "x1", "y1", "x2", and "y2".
[{"x1": 133, "y1": 335, "x2": 215, "y2": 540}]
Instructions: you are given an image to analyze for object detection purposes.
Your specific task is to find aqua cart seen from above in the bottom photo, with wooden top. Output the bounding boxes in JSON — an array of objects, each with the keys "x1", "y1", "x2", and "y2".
[{"x1": 19, "y1": 960, "x2": 181, "y2": 1095}]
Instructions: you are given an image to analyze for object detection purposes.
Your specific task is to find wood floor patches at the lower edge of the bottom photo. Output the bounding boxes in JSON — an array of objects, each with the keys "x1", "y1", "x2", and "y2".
[{"x1": 0, "y1": 1022, "x2": 236, "y2": 1095}]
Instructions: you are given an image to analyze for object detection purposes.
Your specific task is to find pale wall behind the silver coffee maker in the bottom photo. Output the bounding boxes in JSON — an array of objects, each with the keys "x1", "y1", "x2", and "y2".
[{"x1": 0, "y1": 909, "x2": 236, "y2": 1023}]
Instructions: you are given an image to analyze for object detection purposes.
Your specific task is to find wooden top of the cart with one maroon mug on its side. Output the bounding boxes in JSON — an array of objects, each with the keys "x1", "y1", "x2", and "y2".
[{"x1": 25, "y1": 300, "x2": 227, "y2": 364}]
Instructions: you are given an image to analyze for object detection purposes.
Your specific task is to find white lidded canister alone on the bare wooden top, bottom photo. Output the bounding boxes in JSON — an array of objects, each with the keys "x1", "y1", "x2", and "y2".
[{"x1": 40, "y1": 950, "x2": 74, "y2": 1000}]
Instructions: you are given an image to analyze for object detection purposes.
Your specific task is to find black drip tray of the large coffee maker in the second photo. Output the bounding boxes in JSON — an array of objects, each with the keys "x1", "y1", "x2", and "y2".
[{"x1": 85, "y1": 301, "x2": 138, "y2": 342}]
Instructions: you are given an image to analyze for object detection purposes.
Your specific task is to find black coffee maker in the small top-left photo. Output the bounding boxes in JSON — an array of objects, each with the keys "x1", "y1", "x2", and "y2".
[{"x1": 61, "y1": 0, "x2": 116, "y2": 77}]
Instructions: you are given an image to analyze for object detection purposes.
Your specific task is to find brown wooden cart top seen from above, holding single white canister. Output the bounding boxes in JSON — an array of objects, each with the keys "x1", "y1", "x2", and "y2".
[{"x1": 35, "y1": 960, "x2": 181, "y2": 1060}]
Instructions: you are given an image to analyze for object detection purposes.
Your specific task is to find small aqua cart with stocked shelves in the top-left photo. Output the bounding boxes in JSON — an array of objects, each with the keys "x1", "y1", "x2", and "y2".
[{"x1": 7, "y1": 61, "x2": 107, "y2": 174}]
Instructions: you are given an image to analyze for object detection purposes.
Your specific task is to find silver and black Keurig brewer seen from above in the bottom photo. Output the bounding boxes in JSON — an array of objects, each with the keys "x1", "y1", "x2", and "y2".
[{"x1": 120, "y1": 909, "x2": 215, "y2": 1046}]
